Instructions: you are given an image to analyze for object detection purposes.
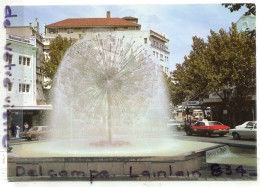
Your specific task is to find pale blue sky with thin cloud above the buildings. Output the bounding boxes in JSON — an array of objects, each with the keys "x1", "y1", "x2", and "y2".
[{"x1": 8, "y1": 4, "x2": 246, "y2": 70}]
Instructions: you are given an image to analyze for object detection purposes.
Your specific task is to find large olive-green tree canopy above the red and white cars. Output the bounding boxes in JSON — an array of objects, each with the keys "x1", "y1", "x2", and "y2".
[{"x1": 173, "y1": 24, "x2": 256, "y2": 106}]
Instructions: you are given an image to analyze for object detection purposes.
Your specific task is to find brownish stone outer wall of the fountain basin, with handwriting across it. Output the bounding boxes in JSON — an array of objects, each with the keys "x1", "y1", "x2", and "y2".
[{"x1": 8, "y1": 145, "x2": 223, "y2": 181}]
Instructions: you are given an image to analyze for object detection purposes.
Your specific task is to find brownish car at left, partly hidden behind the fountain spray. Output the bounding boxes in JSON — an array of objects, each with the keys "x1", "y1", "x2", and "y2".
[{"x1": 20, "y1": 126, "x2": 50, "y2": 140}]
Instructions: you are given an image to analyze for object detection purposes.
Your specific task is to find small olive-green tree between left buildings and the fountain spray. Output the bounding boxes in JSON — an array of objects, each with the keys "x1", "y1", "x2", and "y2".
[{"x1": 41, "y1": 35, "x2": 75, "y2": 86}]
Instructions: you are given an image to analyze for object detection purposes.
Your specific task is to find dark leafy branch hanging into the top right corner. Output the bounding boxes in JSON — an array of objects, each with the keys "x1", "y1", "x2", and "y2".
[{"x1": 222, "y1": 3, "x2": 256, "y2": 15}]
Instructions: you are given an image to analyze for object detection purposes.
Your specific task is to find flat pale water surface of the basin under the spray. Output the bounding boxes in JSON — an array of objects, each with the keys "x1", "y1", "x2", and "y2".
[{"x1": 10, "y1": 137, "x2": 221, "y2": 157}]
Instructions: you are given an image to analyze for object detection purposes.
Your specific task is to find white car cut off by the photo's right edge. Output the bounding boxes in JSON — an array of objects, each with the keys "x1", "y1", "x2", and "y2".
[{"x1": 229, "y1": 121, "x2": 257, "y2": 140}]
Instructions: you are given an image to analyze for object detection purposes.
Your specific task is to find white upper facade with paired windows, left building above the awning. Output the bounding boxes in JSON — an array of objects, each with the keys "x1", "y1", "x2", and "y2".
[{"x1": 6, "y1": 34, "x2": 37, "y2": 106}]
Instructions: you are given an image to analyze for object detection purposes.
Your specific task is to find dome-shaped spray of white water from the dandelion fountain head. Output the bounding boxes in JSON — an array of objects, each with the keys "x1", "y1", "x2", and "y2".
[{"x1": 52, "y1": 34, "x2": 169, "y2": 148}]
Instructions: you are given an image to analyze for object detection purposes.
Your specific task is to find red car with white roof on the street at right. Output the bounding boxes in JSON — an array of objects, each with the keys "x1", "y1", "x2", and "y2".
[{"x1": 185, "y1": 120, "x2": 230, "y2": 136}]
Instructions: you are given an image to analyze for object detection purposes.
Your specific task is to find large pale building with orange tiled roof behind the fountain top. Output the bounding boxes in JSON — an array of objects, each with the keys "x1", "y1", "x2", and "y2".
[{"x1": 43, "y1": 12, "x2": 170, "y2": 76}]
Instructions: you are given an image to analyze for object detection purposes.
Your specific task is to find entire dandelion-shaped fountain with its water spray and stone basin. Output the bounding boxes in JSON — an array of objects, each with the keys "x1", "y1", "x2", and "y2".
[{"x1": 8, "y1": 33, "x2": 233, "y2": 180}]
